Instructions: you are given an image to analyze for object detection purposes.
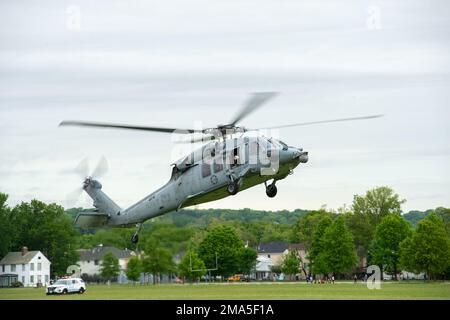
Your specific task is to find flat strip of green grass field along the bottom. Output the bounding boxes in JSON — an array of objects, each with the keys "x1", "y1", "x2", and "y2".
[{"x1": 0, "y1": 282, "x2": 450, "y2": 300}]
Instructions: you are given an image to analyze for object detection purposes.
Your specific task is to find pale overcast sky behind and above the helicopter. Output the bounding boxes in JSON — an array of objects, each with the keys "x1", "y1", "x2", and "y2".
[{"x1": 0, "y1": 0, "x2": 450, "y2": 211}]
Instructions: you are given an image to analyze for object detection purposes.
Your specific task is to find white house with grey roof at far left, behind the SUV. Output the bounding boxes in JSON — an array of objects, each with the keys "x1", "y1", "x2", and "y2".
[{"x1": 0, "y1": 247, "x2": 51, "y2": 287}]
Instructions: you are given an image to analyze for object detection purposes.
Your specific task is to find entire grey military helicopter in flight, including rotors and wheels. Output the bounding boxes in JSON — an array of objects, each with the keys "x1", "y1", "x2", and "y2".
[{"x1": 60, "y1": 92, "x2": 381, "y2": 243}]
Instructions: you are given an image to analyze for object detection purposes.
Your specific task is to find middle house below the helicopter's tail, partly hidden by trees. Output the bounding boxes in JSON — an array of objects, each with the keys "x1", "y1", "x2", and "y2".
[{"x1": 77, "y1": 244, "x2": 135, "y2": 282}]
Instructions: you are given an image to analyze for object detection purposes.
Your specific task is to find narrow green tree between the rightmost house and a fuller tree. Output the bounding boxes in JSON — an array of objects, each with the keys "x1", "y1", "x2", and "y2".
[{"x1": 308, "y1": 216, "x2": 333, "y2": 274}]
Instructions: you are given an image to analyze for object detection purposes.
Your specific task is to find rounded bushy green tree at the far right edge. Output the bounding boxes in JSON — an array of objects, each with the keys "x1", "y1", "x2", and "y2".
[{"x1": 400, "y1": 212, "x2": 450, "y2": 278}]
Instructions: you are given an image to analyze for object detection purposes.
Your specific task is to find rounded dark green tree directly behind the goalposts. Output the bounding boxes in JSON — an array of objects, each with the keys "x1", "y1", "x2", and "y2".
[{"x1": 198, "y1": 225, "x2": 244, "y2": 276}]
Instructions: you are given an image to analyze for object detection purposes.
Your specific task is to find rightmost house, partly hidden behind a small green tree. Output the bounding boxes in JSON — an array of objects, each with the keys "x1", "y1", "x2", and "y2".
[{"x1": 255, "y1": 241, "x2": 308, "y2": 280}]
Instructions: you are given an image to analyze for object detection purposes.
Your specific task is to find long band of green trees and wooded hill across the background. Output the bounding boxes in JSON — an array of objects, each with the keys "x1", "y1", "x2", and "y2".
[{"x1": 0, "y1": 187, "x2": 450, "y2": 281}]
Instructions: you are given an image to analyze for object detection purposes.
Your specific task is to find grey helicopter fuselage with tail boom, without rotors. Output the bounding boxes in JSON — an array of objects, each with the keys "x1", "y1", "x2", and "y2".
[{"x1": 78, "y1": 137, "x2": 308, "y2": 226}]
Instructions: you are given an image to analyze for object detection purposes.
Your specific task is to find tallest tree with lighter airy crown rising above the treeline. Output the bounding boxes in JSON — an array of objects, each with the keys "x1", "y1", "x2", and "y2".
[{"x1": 346, "y1": 187, "x2": 405, "y2": 258}]
